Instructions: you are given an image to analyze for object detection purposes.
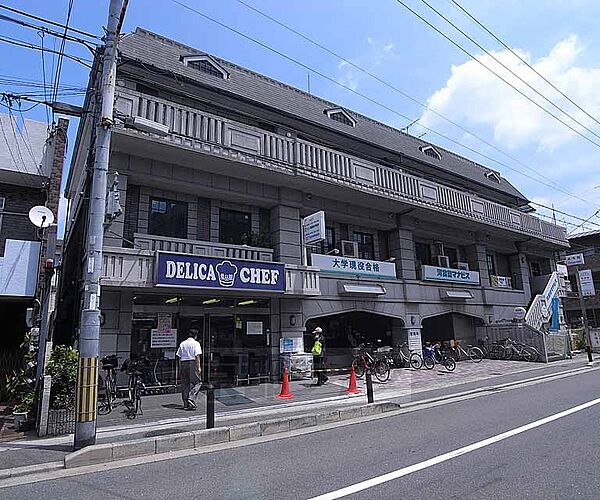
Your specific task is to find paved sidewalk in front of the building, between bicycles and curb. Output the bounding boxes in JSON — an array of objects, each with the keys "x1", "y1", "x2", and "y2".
[{"x1": 0, "y1": 356, "x2": 587, "y2": 470}]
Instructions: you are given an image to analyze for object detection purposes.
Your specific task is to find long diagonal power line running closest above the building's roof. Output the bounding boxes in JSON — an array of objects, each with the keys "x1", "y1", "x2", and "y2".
[{"x1": 171, "y1": 0, "x2": 593, "y2": 211}]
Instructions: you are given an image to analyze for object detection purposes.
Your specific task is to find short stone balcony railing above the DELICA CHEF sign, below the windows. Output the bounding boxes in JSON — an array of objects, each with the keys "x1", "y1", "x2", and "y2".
[{"x1": 133, "y1": 233, "x2": 273, "y2": 262}]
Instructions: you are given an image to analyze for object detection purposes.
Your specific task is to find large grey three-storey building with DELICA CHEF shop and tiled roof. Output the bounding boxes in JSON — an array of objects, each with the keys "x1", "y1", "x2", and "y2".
[{"x1": 60, "y1": 29, "x2": 568, "y2": 383}]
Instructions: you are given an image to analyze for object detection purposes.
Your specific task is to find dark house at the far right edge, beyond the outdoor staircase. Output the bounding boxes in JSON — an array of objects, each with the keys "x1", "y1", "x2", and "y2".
[{"x1": 564, "y1": 230, "x2": 600, "y2": 328}]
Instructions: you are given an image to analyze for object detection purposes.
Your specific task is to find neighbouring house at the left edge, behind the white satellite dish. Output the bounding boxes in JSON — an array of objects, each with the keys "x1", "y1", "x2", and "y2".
[{"x1": 0, "y1": 115, "x2": 68, "y2": 372}]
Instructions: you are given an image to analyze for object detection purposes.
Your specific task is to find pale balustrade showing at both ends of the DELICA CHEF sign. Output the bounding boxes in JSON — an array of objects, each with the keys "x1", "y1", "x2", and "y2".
[{"x1": 102, "y1": 247, "x2": 321, "y2": 296}]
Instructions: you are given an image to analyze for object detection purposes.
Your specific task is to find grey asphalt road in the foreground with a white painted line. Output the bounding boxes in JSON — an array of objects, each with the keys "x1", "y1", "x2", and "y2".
[{"x1": 0, "y1": 370, "x2": 600, "y2": 500}]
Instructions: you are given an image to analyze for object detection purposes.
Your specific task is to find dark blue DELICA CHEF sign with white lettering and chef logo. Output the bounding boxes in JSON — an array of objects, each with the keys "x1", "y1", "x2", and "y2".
[{"x1": 156, "y1": 252, "x2": 285, "y2": 292}]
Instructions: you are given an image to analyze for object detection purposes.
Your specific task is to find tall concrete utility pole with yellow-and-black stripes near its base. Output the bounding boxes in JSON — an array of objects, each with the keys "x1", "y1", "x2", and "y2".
[{"x1": 74, "y1": 0, "x2": 127, "y2": 449}]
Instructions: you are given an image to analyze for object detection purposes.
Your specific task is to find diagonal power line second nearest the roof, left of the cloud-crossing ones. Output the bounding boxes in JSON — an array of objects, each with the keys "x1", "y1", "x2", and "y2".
[{"x1": 229, "y1": 0, "x2": 591, "y2": 211}]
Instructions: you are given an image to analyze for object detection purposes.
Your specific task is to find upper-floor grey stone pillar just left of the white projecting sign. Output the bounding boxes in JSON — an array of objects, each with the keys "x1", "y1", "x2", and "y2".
[{"x1": 271, "y1": 204, "x2": 302, "y2": 264}]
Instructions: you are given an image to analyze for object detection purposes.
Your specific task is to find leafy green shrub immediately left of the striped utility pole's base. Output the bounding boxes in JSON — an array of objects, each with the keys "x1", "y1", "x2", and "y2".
[{"x1": 48, "y1": 346, "x2": 79, "y2": 410}]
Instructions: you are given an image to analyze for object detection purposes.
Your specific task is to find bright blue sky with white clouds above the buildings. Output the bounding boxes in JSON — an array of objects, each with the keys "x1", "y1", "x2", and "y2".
[{"x1": 0, "y1": 0, "x2": 600, "y2": 232}]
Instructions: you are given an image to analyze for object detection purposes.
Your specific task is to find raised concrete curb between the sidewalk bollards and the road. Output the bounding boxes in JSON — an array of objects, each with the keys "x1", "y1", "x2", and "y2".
[{"x1": 63, "y1": 402, "x2": 400, "y2": 468}]
